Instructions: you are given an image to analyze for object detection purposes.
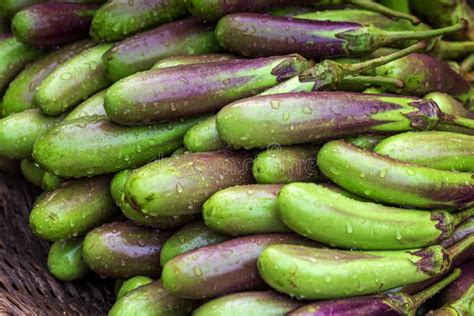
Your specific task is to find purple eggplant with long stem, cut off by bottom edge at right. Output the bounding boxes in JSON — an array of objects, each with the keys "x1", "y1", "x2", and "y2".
[{"x1": 286, "y1": 269, "x2": 461, "y2": 316}]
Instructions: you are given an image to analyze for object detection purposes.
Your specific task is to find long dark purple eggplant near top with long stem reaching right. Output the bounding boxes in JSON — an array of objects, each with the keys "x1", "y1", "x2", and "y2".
[{"x1": 216, "y1": 13, "x2": 467, "y2": 59}]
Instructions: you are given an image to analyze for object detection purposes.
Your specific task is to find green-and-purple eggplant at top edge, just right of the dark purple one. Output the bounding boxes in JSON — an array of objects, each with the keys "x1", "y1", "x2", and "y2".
[{"x1": 90, "y1": 0, "x2": 186, "y2": 42}]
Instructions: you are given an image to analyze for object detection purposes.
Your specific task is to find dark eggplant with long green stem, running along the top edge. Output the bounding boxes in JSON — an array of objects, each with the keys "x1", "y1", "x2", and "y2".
[{"x1": 185, "y1": 0, "x2": 419, "y2": 23}]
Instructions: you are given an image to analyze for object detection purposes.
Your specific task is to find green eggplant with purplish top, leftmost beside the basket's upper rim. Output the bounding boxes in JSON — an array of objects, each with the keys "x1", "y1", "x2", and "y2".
[{"x1": 30, "y1": 176, "x2": 115, "y2": 241}]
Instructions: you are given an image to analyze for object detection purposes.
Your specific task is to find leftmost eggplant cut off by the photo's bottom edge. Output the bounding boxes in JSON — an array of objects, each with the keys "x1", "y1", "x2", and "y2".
[{"x1": 108, "y1": 281, "x2": 198, "y2": 316}]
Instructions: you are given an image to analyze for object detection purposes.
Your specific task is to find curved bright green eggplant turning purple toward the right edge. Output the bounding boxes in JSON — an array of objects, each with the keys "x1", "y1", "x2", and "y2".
[{"x1": 317, "y1": 141, "x2": 474, "y2": 210}]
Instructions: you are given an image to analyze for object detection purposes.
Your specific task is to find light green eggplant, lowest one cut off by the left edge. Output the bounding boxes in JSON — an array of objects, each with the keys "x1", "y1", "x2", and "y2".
[{"x1": 0, "y1": 109, "x2": 61, "y2": 159}]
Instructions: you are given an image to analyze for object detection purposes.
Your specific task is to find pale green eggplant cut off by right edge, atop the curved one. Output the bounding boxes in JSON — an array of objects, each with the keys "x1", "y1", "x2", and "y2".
[{"x1": 373, "y1": 131, "x2": 474, "y2": 172}]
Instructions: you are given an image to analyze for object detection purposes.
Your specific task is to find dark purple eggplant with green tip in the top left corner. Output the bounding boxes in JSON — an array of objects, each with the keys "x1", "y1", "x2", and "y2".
[{"x1": 12, "y1": 3, "x2": 100, "y2": 48}]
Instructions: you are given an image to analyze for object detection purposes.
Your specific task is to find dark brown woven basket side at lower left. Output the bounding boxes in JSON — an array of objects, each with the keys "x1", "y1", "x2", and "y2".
[{"x1": 0, "y1": 173, "x2": 113, "y2": 316}]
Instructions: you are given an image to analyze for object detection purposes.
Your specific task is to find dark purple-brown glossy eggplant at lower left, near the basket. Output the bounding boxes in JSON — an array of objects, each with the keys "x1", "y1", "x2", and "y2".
[{"x1": 82, "y1": 222, "x2": 170, "y2": 278}]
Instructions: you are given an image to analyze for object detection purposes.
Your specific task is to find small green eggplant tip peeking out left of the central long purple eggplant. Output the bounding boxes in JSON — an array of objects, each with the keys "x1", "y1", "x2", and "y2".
[{"x1": 183, "y1": 115, "x2": 227, "y2": 153}]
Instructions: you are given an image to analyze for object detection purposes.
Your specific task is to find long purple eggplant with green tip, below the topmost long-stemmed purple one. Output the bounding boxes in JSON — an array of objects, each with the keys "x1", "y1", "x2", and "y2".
[{"x1": 105, "y1": 55, "x2": 311, "y2": 125}]
